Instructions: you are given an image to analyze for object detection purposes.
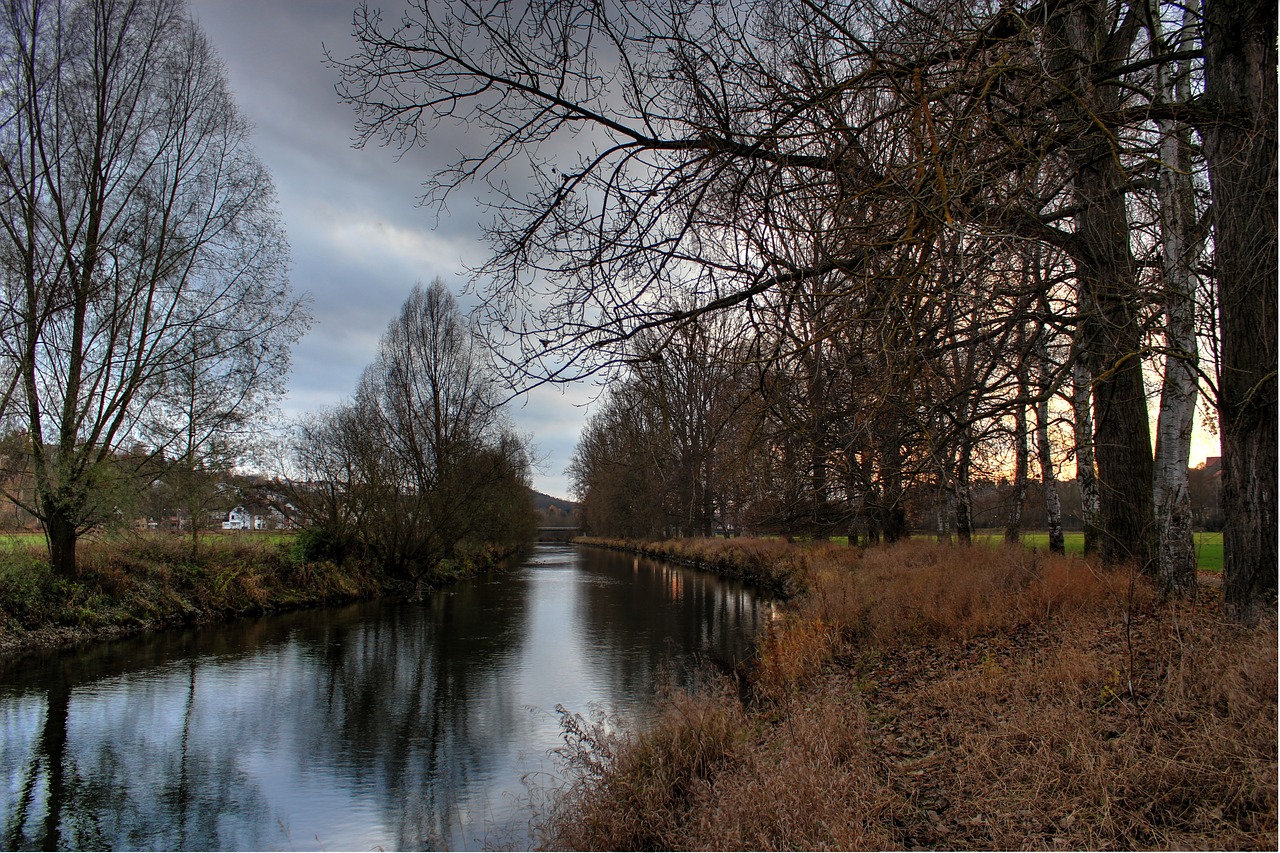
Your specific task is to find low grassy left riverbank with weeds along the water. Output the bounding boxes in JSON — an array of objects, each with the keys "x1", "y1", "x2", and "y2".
[{"x1": 0, "y1": 535, "x2": 509, "y2": 654}]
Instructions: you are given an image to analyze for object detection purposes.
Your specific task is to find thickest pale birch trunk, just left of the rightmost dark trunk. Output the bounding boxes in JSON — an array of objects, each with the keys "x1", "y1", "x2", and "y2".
[{"x1": 1151, "y1": 0, "x2": 1203, "y2": 597}]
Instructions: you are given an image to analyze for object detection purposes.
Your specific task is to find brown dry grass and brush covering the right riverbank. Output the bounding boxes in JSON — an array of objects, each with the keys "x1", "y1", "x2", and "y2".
[{"x1": 540, "y1": 540, "x2": 1277, "y2": 850}]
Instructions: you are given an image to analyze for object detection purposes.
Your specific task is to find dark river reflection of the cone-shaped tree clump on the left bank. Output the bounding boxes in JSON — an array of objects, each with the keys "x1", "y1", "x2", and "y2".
[{"x1": 306, "y1": 574, "x2": 537, "y2": 848}]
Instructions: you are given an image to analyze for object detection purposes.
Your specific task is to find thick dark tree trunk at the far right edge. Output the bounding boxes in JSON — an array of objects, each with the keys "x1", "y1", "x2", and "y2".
[{"x1": 1201, "y1": 0, "x2": 1280, "y2": 624}]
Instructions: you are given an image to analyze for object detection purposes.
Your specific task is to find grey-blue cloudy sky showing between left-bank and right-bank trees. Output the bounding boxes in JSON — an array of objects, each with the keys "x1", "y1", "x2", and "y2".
[{"x1": 191, "y1": 0, "x2": 594, "y2": 497}]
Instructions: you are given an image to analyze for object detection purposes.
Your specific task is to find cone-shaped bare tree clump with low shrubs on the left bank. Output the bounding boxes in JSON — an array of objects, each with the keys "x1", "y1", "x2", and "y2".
[{"x1": 288, "y1": 279, "x2": 536, "y2": 583}]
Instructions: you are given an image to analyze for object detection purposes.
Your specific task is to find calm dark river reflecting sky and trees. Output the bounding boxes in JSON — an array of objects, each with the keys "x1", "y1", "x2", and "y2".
[{"x1": 0, "y1": 544, "x2": 769, "y2": 850}]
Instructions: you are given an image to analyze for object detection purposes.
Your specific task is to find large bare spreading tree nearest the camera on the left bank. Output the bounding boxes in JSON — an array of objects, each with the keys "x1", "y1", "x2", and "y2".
[{"x1": 0, "y1": 0, "x2": 303, "y2": 575}]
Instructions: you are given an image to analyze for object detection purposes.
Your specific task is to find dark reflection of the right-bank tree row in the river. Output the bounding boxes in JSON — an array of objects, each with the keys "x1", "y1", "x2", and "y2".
[{"x1": 579, "y1": 549, "x2": 762, "y2": 694}]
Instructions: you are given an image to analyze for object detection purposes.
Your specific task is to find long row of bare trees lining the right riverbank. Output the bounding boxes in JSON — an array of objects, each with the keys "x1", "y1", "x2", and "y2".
[{"x1": 330, "y1": 0, "x2": 1277, "y2": 621}]
